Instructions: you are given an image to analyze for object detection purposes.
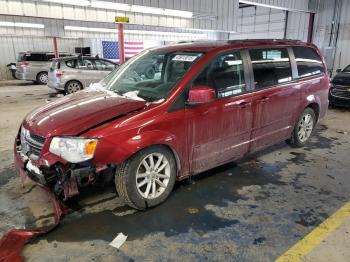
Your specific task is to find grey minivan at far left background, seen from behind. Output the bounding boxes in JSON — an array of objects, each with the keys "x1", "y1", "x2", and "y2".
[{"x1": 15, "y1": 52, "x2": 70, "y2": 85}]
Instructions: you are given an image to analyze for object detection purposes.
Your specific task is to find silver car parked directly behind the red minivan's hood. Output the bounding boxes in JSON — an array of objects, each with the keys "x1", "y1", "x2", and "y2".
[{"x1": 47, "y1": 56, "x2": 118, "y2": 94}]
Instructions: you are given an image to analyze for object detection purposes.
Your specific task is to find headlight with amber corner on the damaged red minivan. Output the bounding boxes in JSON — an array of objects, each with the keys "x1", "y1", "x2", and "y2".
[{"x1": 49, "y1": 137, "x2": 97, "y2": 163}]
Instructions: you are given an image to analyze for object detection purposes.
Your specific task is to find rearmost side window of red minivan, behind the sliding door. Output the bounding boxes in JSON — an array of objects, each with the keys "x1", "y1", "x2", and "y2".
[{"x1": 293, "y1": 46, "x2": 325, "y2": 78}]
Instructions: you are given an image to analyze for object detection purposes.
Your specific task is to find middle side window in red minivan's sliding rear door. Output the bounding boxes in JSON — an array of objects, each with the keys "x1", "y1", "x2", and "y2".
[{"x1": 249, "y1": 48, "x2": 292, "y2": 89}]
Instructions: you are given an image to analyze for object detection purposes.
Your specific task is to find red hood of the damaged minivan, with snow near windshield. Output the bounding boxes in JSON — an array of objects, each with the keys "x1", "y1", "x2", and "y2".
[{"x1": 23, "y1": 91, "x2": 146, "y2": 137}]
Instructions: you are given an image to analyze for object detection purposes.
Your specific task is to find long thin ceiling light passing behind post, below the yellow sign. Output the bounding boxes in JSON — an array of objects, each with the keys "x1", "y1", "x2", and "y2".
[{"x1": 64, "y1": 26, "x2": 207, "y2": 39}]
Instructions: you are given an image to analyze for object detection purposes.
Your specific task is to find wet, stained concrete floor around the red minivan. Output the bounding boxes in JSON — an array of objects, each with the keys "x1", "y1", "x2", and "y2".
[{"x1": 0, "y1": 81, "x2": 350, "y2": 261}]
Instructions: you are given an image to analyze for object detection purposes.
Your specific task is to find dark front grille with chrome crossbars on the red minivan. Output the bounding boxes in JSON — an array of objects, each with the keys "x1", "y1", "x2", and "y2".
[{"x1": 21, "y1": 127, "x2": 45, "y2": 159}]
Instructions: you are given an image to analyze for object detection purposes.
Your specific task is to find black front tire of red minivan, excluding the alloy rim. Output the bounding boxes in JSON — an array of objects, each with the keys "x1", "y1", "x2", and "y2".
[{"x1": 115, "y1": 145, "x2": 177, "y2": 210}]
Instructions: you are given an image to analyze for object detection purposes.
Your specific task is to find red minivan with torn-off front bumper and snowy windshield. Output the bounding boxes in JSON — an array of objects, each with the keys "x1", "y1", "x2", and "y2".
[{"x1": 14, "y1": 40, "x2": 329, "y2": 209}]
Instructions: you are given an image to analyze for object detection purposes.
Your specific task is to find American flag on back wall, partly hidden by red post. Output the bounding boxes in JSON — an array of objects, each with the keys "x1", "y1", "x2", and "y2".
[{"x1": 102, "y1": 41, "x2": 144, "y2": 60}]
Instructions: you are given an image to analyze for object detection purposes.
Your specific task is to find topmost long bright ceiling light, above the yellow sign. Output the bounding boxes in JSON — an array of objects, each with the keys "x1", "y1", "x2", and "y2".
[{"x1": 42, "y1": 0, "x2": 193, "y2": 18}]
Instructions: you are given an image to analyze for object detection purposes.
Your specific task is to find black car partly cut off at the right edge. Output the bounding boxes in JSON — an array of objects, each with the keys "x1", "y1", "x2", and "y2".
[{"x1": 329, "y1": 65, "x2": 350, "y2": 106}]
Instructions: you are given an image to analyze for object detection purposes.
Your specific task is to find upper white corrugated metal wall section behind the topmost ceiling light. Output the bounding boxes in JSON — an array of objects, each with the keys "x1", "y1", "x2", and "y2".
[{"x1": 0, "y1": 0, "x2": 238, "y2": 31}]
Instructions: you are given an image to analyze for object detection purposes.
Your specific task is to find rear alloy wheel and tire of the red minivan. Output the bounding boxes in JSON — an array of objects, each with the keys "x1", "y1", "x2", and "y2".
[{"x1": 287, "y1": 108, "x2": 316, "y2": 147}]
